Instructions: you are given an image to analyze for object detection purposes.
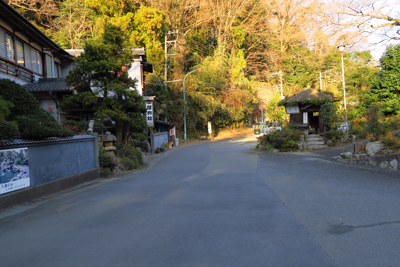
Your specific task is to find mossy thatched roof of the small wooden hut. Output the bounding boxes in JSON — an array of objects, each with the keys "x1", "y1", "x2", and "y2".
[{"x1": 278, "y1": 89, "x2": 337, "y2": 106}]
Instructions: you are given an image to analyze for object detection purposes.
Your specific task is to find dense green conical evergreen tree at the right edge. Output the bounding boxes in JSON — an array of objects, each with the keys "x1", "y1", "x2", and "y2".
[{"x1": 365, "y1": 45, "x2": 400, "y2": 115}]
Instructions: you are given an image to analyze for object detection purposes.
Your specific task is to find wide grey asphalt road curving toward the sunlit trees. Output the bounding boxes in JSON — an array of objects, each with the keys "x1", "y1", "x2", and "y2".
[{"x1": 0, "y1": 136, "x2": 400, "y2": 267}]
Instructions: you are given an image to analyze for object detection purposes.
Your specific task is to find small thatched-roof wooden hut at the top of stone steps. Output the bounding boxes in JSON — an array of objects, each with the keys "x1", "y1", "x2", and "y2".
[{"x1": 279, "y1": 89, "x2": 336, "y2": 135}]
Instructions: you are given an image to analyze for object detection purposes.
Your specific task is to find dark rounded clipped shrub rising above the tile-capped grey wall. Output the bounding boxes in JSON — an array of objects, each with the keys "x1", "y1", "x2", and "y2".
[{"x1": 0, "y1": 79, "x2": 74, "y2": 139}]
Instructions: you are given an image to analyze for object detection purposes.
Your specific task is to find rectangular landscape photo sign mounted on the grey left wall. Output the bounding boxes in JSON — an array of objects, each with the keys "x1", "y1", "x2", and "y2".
[{"x1": 0, "y1": 148, "x2": 30, "y2": 195}]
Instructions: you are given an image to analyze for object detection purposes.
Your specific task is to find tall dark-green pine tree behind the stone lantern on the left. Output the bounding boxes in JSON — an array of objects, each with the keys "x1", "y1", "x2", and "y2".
[{"x1": 64, "y1": 24, "x2": 146, "y2": 146}]
